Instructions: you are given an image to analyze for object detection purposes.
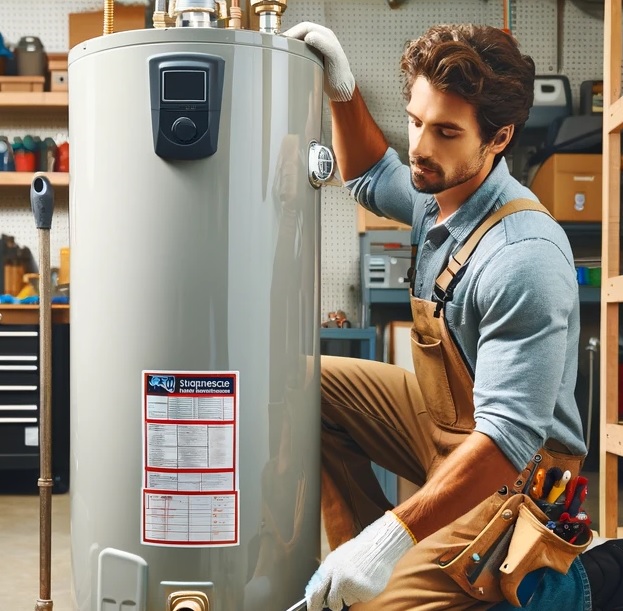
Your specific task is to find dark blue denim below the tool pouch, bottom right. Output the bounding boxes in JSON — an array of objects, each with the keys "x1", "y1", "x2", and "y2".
[{"x1": 492, "y1": 558, "x2": 592, "y2": 611}]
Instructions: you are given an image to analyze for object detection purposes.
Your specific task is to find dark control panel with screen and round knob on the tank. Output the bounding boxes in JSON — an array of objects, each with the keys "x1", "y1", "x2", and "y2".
[{"x1": 149, "y1": 53, "x2": 225, "y2": 159}]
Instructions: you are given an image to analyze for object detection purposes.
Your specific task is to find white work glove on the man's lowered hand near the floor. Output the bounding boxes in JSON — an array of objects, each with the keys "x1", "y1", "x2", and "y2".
[{"x1": 305, "y1": 511, "x2": 416, "y2": 611}]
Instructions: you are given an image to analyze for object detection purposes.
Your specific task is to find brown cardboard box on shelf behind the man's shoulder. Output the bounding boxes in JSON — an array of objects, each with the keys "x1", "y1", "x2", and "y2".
[{"x1": 530, "y1": 153, "x2": 602, "y2": 223}]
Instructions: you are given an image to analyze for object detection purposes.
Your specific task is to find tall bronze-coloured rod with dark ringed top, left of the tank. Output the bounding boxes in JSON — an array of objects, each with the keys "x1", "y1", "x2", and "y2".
[{"x1": 30, "y1": 175, "x2": 54, "y2": 611}]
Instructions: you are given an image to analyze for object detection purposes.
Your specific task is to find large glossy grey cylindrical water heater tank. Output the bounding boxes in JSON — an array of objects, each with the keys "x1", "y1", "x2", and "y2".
[{"x1": 69, "y1": 29, "x2": 323, "y2": 611}]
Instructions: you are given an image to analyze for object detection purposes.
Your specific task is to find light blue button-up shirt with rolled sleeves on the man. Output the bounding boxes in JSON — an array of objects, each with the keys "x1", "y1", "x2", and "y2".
[{"x1": 347, "y1": 148, "x2": 586, "y2": 470}]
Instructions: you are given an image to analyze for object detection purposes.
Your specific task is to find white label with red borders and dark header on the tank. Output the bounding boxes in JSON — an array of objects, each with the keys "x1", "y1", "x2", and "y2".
[{"x1": 142, "y1": 371, "x2": 240, "y2": 547}]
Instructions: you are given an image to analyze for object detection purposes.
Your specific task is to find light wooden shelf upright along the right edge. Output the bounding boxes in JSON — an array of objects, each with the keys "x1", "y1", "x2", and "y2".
[{"x1": 599, "y1": 0, "x2": 623, "y2": 537}]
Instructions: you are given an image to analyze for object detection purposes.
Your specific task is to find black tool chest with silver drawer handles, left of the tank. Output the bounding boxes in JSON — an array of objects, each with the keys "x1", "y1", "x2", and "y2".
[{"x1": 0, "y1": 321, "x2": 69, "y2": 492}]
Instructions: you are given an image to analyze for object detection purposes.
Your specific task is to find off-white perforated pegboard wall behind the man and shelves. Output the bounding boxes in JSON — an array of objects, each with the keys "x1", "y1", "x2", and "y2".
[{"x1": 0, "y1": 0, "x2": 603, "y2": 321}]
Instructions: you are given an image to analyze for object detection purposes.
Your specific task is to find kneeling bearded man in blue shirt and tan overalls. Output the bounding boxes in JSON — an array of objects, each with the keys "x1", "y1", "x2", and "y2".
[{"x1": 285, "y1": 23, "x2": 623, "y2": 611}]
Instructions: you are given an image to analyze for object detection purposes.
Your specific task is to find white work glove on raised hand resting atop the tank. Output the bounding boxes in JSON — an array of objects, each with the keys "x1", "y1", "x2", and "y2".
[{"x1": 283, "y1": 21, "x2": 355, "y2": 102}]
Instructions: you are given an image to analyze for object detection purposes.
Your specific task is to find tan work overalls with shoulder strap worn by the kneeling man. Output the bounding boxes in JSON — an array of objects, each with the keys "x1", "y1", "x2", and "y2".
[{"x1": 322, "y1": 200, "x2": 585, "y2": 611}]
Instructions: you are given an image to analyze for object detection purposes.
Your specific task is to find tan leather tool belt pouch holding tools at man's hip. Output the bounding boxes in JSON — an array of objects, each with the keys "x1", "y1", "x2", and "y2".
[{"x1": 438, "y1": 450, "x2": 593, "y2": 607}]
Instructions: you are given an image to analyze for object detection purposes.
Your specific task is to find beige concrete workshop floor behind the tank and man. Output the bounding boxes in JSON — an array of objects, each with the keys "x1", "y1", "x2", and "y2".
[{"x1": 0, "y1": 473, "x2": 623, "y2": 611}]
